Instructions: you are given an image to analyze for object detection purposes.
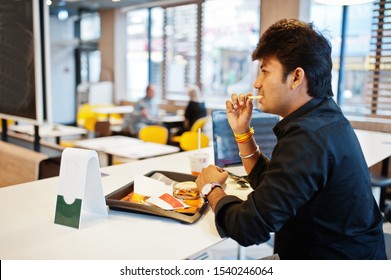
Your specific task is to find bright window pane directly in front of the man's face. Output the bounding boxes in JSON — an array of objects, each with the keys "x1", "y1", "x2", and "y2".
[{"x1": 201, "y1": 0, "x2": 260, "y2": 104}]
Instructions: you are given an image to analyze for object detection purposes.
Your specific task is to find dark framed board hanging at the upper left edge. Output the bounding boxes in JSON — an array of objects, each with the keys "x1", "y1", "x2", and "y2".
[{"x1": 0, "y1": 0, "x2": 50, "y2": 124}]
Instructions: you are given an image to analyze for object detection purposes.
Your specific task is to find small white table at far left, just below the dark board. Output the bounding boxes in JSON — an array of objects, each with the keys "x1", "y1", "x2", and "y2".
[{"x1": 9, "y1": 124, "x2": 88, "y2": 144}]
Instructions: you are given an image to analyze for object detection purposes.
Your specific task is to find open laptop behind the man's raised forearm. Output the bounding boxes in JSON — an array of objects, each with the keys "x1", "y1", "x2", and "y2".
[{"x1": 212, "y1": 109, "x2": 280, "y2": 176}]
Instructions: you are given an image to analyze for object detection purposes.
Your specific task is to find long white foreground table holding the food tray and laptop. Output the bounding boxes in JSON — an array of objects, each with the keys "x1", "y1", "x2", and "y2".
[{"x1": 0, "y1": 148, "x2": 251, "y2": 260}]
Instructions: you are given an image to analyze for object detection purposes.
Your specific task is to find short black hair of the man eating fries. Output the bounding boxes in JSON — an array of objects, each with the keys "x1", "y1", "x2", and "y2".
[{"x1": 252, "y1": 19, "x2": 333, "y2": 98}]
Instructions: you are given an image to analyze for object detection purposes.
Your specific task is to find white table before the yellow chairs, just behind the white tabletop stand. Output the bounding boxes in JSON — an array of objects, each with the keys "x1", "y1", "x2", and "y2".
[{"x1": 75, "y1": 135, "x2": 180, "y2": 165}]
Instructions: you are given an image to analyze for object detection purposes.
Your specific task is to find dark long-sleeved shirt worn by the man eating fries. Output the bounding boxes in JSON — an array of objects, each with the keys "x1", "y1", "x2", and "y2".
[{"x1": 216, "y1": 98, "x2": 386, "y2": 259}]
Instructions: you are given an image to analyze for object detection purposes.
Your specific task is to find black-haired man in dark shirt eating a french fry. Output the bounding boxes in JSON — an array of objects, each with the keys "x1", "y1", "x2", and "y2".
[{"x1": 196, "y1": 19, "x2": 386, "y2": 259}]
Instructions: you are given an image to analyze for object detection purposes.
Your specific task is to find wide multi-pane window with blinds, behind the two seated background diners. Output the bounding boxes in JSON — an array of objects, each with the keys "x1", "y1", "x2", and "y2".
[{"x1": 127, "y1": 0, "x2": 260, "y2": 104}]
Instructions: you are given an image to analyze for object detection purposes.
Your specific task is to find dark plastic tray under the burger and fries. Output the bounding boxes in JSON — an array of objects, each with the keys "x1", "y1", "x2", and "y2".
[{"x1": 106, "y1": 171, "x2": 209, "y2": 224}]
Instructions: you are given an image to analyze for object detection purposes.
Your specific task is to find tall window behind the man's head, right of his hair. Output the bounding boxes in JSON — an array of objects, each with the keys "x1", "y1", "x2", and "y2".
[{"x1": 311, "y1": 2, "x2": 373, "y2": 116}]
